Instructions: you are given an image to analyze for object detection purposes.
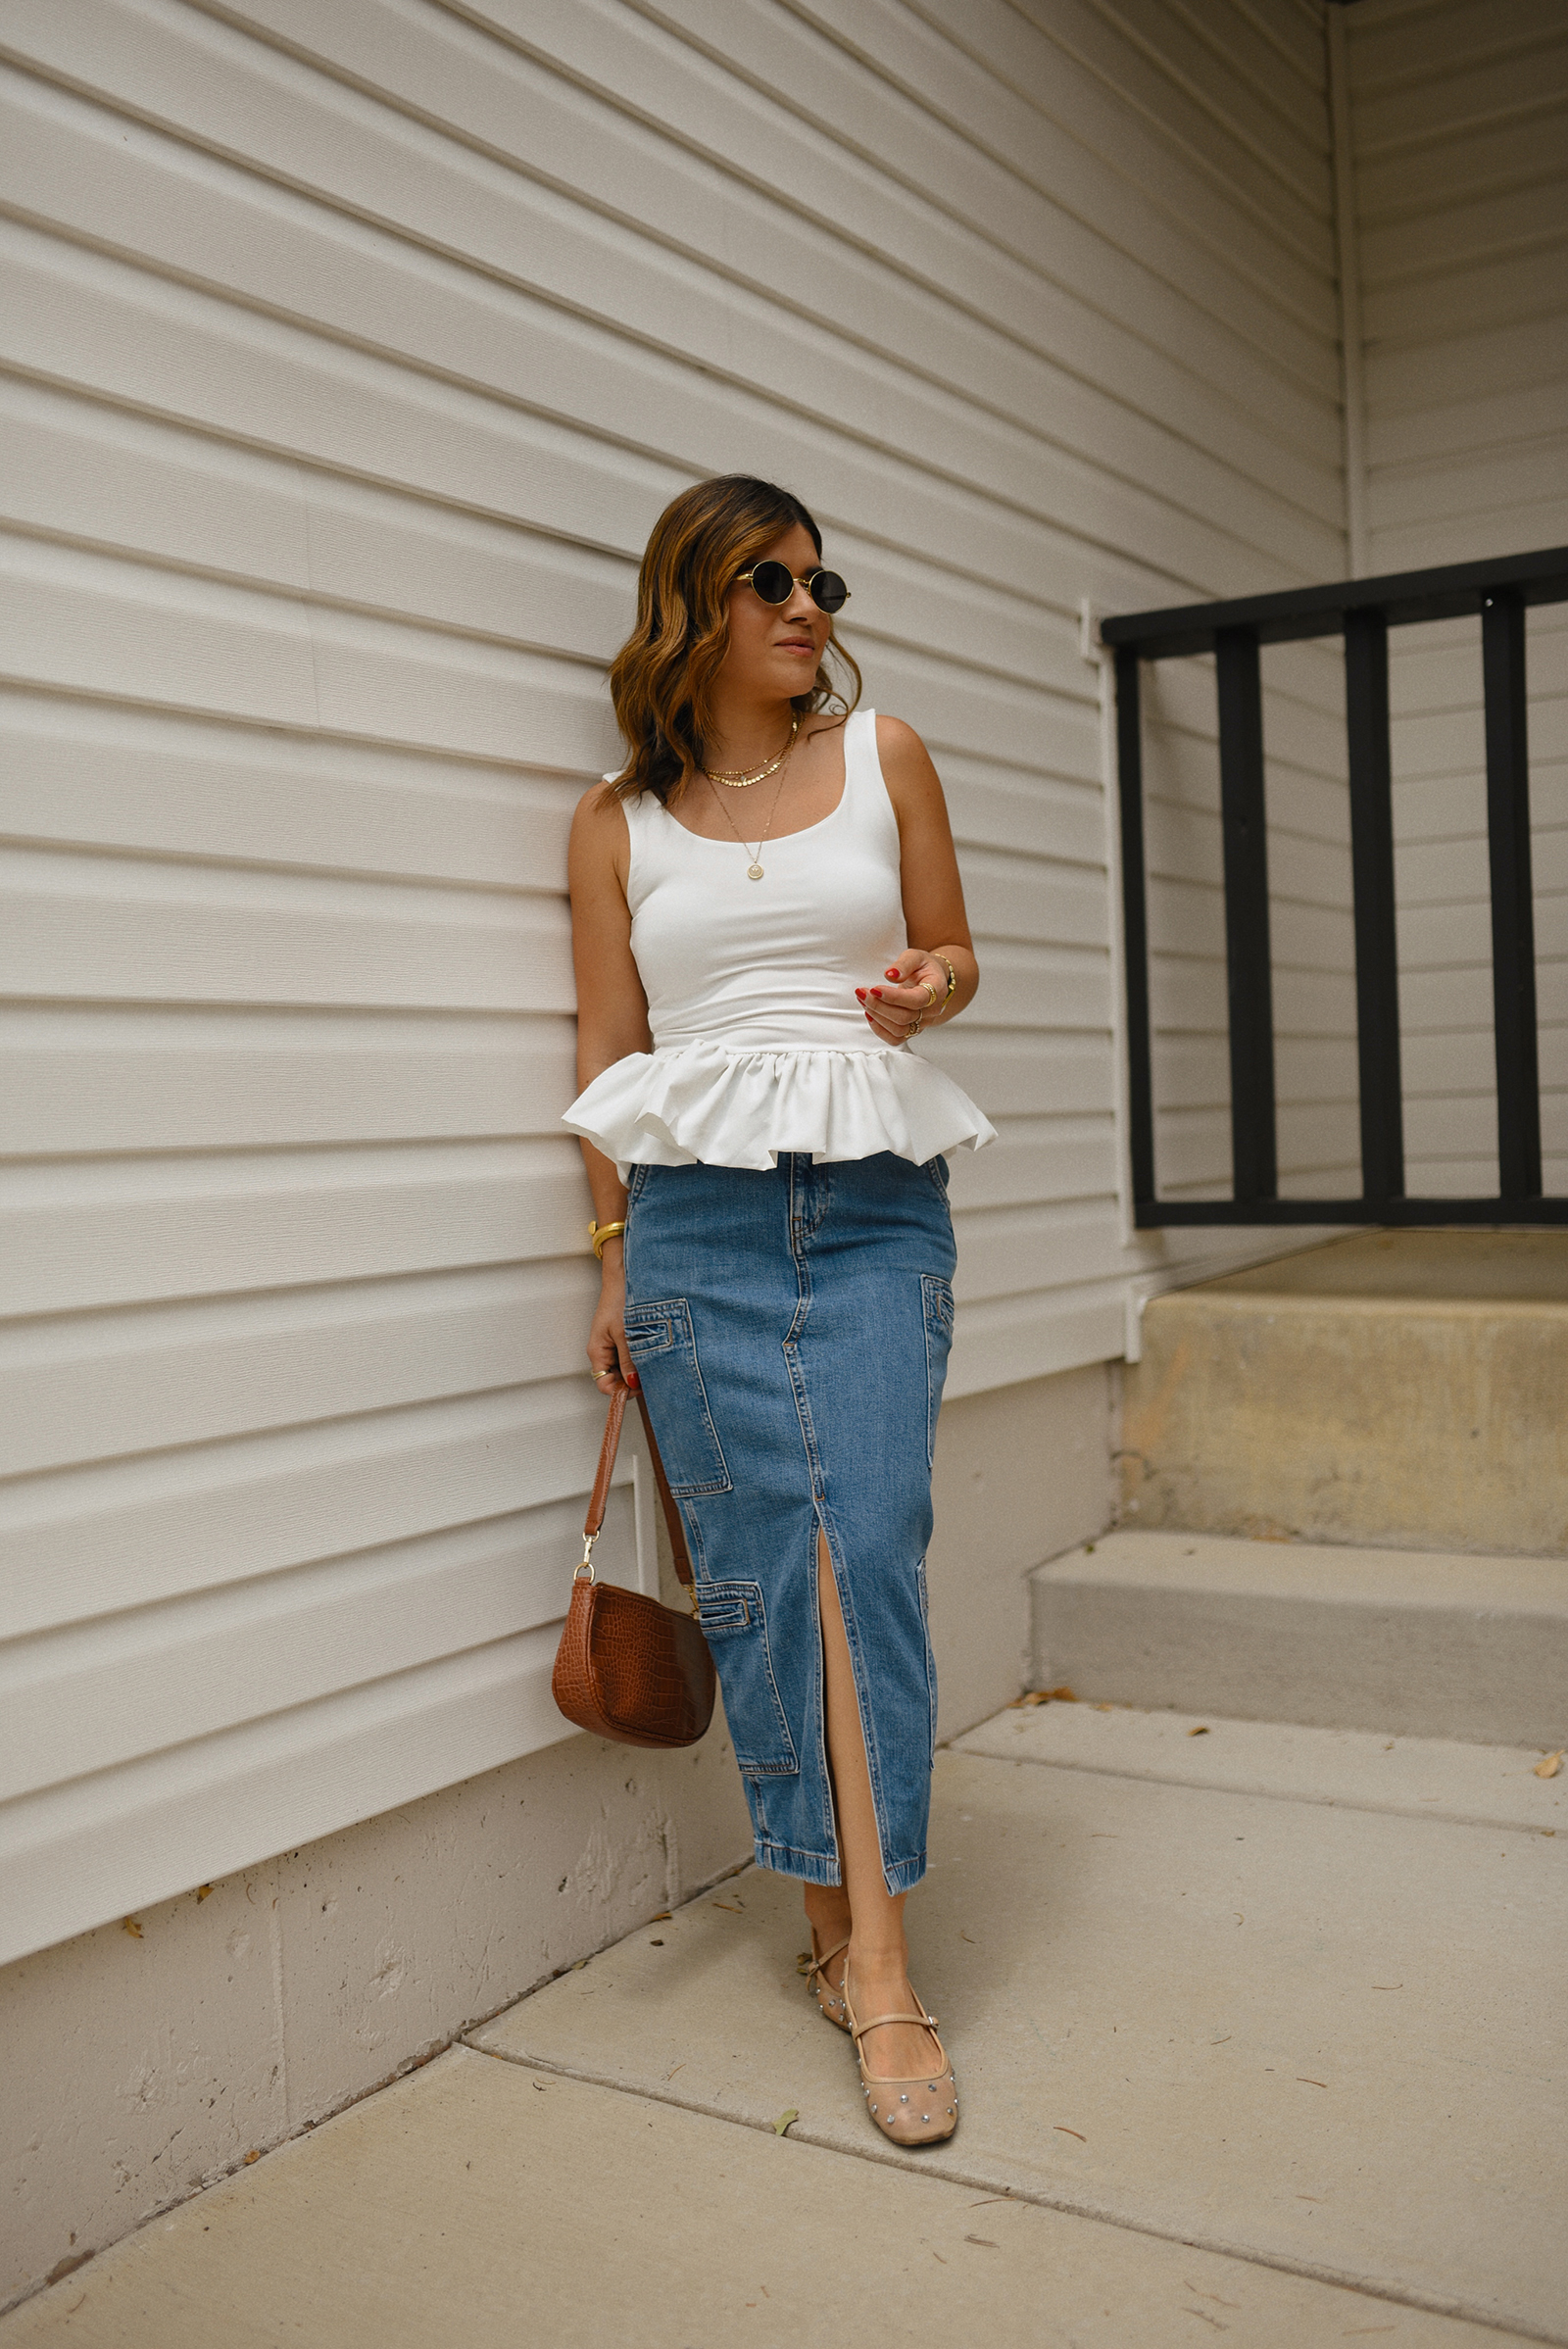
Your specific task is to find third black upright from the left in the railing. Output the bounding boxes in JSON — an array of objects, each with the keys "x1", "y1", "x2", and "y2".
[{"x1": 1345, "y1": 611, "x2": 1403, "y2": 1207}]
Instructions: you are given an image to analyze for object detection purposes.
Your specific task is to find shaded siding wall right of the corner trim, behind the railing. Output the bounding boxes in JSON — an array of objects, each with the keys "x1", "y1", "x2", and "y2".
[{"x1": 1348, "y1": 0, "x2": 1568, "y2": 1196}]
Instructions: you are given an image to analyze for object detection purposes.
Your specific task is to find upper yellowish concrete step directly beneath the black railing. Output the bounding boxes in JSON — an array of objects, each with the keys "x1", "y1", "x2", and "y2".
[{"x1": 1122, "y1": 1231, "x2": 1568, "y2": 1555}]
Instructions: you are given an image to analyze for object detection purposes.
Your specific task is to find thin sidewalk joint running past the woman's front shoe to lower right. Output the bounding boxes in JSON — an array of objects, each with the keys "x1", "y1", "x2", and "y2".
[{"x1": 458, "y1": 2030, "x2": 1568, "y2": 2349}]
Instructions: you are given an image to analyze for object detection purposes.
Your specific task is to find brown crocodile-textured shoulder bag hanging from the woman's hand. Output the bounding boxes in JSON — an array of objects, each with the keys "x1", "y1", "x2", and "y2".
[{"x1": 549, "y1": 1386, "x2": 713, "y2": 1745}]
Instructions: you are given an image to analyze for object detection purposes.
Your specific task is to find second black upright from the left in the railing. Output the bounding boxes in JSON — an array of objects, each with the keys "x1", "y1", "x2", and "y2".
[{"x1": 1213, "y1": 627, "x2": 1279, "y2": 1202}]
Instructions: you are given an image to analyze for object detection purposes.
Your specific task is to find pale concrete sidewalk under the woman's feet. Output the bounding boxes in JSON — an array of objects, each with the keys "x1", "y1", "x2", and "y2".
[{"x1": 0, "y1": 1705, "x2": 1568, "y2": 2349}]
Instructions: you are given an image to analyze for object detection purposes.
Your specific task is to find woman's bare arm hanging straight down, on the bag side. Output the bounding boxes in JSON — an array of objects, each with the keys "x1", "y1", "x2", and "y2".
[{"x1": 565, "y1": 785, "x2": 653, "y2": 1384}]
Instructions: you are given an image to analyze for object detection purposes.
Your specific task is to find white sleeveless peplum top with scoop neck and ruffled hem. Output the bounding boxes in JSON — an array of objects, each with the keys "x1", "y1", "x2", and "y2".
[{"x1": 564, "y1": 710, "x2": 996, "y2": 1182}]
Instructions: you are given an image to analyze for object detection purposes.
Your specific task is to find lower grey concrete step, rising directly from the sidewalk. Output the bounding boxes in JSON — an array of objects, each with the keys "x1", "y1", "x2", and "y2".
[{"x1": 1030, "y1": 1532, "x2": 1568, "y2": 1747}]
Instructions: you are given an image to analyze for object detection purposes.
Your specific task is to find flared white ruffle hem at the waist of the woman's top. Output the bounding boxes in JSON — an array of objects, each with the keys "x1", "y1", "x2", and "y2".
[{"x1": 564, "y1": 1041, "x2": 996, "y2": 1182}]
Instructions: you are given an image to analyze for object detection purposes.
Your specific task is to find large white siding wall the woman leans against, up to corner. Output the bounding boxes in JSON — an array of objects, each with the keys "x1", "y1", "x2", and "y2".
[{"x1": 0, "y1": 0, "x2": 1345, "y2": 1954}]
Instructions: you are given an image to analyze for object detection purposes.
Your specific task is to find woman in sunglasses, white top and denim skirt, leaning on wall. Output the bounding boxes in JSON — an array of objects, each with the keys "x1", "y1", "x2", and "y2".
[{"x1": 565, "y1": 474, "x2": 993, "y2": 2144}]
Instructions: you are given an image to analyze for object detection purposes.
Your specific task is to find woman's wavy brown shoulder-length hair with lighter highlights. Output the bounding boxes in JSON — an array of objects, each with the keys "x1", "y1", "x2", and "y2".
[{"x1": 611, "y1": 472, "x2": 861, "y2": 801}]
